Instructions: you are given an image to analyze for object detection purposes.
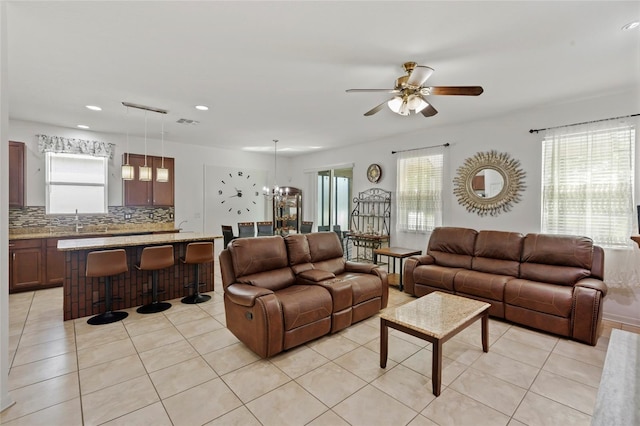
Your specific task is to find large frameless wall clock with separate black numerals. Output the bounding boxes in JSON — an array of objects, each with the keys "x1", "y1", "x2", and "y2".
[{"x1": 218, "y1": 171, "x2": 260, "y2": 215}]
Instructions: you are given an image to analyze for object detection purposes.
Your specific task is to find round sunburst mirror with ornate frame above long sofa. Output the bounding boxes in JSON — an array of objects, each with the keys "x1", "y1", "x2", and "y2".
[{"x1": 453, "y1": 151, "x2": 525, "y2": 216}]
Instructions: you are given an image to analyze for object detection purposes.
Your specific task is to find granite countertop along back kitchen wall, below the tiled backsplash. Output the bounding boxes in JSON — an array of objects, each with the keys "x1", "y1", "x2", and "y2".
[{"x1": 9, "y1": 223, "x2": 180, "y2": 240}]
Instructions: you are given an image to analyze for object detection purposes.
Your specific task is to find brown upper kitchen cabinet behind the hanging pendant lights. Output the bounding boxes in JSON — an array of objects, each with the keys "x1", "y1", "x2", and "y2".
[{"x1": 122, "y1": 154, "x2": 175, "y2": 207}]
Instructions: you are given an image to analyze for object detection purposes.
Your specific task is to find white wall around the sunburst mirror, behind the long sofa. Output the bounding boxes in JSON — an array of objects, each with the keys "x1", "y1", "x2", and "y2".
[{"x1": 292, "y1": 88, "x2": 640, "y2": 325}]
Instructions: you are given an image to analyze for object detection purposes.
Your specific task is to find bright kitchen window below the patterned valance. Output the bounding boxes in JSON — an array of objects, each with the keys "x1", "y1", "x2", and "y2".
[{"x1": 45, "y1": 152, "x2": 109, "y2": 214}]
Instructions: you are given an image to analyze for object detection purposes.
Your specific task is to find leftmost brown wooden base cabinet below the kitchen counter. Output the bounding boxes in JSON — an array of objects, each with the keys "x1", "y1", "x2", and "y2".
[{"x1": 9, "y1": 238, "x2": 44, "y2": 293}]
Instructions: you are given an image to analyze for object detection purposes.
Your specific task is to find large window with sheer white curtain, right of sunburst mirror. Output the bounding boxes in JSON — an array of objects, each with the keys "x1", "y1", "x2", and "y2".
[{"x1": 542, "y1": 122, "x2": 635, "y2": 247}]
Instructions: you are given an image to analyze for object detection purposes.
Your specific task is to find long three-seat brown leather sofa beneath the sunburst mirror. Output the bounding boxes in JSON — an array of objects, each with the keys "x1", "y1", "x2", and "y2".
[{"x1": 404, "y1": 227, "x2": 607, "y2": 345}]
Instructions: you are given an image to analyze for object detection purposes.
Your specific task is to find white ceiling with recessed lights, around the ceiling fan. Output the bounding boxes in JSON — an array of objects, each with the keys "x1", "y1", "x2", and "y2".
[{"x1": 3, "y1": 1, "x2": 640, "y2": 155}]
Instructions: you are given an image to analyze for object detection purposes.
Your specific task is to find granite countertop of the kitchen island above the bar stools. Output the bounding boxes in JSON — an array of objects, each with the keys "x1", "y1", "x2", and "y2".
[{"x1": 58, "y1": 232, "x2": 222, "y2": 251}]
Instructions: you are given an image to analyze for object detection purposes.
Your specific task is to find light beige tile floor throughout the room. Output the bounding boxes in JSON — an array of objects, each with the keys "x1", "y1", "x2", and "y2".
[{"x1": 0, "y1": 274, "x2": 640, "y2": 426}]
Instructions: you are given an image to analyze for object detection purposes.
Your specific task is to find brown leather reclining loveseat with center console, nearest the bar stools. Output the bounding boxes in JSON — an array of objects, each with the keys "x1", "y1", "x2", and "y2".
[{"x1": 220, "y1": 232, "x2": 389, "y2": 357}]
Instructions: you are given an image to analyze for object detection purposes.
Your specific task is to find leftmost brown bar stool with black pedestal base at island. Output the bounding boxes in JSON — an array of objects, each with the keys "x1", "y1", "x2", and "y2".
[{"x1": 85, "y1": 249, "x2": 129, "y2": 325}]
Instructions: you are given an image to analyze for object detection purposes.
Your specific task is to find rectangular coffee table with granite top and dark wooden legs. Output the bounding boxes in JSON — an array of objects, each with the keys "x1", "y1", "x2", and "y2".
[{"x1": 380, "y1": 291, "x2": 491, "y2": 396}]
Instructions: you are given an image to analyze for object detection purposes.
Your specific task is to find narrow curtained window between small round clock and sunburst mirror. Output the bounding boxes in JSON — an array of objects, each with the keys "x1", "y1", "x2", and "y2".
[{"x1": 396, "y1": 150, "x2": 444, "y2": 232}]
